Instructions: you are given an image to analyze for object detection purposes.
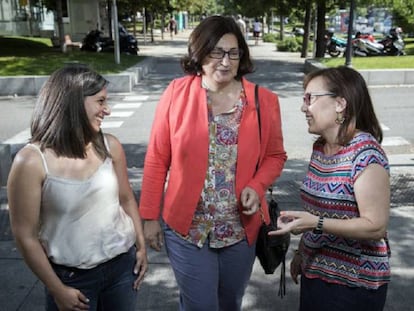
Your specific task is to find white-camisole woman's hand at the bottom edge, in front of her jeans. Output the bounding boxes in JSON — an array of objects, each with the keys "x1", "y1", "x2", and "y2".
[{"x1": 54, "y1": 286, "x2": 89, "y2": 311}]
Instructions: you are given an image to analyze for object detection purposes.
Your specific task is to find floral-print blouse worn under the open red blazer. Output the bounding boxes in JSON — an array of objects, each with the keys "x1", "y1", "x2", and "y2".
[{"x1": 177, "y1": 91, "x2": 246, "y2": 248}]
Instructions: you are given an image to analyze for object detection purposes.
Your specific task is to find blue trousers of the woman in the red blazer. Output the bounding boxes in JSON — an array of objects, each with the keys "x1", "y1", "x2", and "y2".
[{"x1": 164, "y1": 225, "x2": 256, "y2": 311}]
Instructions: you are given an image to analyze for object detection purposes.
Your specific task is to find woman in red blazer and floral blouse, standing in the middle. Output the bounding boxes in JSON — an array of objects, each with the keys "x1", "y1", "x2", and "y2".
[{"x1": 139, "y1": 16, "x2": 286, "y2": 311}]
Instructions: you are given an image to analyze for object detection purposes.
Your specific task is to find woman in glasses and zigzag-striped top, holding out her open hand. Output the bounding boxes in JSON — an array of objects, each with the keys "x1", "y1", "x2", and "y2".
[{"x1": 271, "y1": 66, "x2": 390, "y2": 311}]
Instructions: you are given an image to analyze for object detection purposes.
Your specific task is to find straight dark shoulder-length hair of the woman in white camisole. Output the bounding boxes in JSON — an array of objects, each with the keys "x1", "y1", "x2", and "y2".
[{"x1": 30, "y1": 65, "x2": 109, "y2": 158}]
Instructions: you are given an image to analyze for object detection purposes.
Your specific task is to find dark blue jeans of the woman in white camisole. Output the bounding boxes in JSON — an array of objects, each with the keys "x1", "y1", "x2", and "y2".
[{"x1": 46, "y1": 246, "x2": 138, "y2": 311}]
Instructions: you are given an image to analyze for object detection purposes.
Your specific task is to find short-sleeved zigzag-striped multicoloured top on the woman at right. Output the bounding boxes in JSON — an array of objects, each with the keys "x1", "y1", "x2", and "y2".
[{"x1": 300, "y1": 133, "x2": 391, "y2": 289}]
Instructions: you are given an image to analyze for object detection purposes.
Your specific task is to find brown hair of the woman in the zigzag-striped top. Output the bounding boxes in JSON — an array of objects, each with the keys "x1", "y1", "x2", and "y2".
[{"x1": 303, "y1": 66, "x2": 383, "y2": 145}]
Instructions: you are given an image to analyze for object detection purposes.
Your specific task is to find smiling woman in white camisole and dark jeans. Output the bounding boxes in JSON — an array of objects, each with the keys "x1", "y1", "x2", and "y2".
[{"x1": 7, "y1": 66, "x2": 147, "y2": 311}]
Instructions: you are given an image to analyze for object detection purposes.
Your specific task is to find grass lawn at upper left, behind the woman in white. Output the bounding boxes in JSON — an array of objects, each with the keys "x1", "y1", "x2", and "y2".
[{"x1": 0, "y1": 36, "x2": 144, "y2": 76}]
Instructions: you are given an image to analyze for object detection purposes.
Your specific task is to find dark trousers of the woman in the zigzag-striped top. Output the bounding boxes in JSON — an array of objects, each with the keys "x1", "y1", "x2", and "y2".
[{"x1": 299, "y1": 276, "x2": 388, "y2": 311}]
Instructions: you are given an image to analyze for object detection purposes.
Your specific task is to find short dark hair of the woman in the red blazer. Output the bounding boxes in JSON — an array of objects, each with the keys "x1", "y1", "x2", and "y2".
[{"x1": 181, "y1": 15, "x2": 254, "y2": 80}]
